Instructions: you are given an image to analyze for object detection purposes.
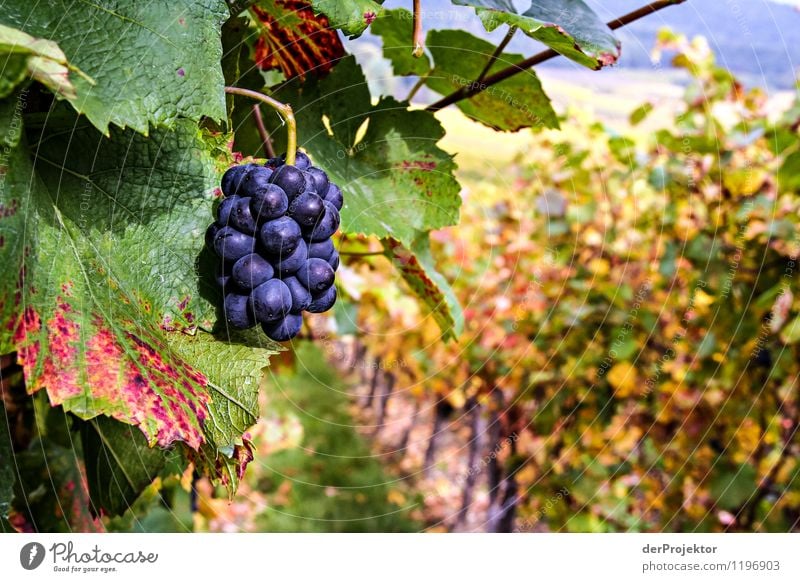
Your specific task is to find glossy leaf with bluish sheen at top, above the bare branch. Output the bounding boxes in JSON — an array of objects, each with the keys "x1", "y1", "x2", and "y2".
[{"x1": 452, "y1": 0, "x2": 620, "y2": 69}]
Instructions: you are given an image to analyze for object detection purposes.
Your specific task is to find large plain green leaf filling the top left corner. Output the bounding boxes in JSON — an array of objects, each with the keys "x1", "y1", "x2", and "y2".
[{"x1": 0, "y1": 0, "x2": 228, "y2": 133}]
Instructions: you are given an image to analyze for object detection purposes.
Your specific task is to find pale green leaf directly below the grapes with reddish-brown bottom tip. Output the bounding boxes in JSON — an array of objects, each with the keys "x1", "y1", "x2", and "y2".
[{"x1": 171, "y1": 332, "x2": 283, "y2": 494}]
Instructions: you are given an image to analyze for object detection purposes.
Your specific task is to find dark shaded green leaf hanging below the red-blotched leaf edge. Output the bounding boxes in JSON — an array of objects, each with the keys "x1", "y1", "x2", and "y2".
[{"x1": 81, "y1": 416, "x2": 172, "y2": 515}]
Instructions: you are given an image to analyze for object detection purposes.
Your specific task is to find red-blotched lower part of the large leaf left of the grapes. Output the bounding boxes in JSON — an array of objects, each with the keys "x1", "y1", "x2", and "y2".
[{"x1": 15, "y1": 296, "x2": 210, "y2": 449}]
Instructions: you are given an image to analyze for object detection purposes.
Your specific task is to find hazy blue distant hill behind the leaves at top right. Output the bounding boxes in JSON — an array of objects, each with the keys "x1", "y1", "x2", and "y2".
[{"x1": 374, "y1": 0, "x2": 800, "y2": 89}]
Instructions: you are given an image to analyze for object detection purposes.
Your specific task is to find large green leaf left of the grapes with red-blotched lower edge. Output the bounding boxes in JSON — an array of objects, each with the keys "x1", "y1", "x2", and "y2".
[{"x1": 0, "y1": 106, "x2": 278, "y2": 460}]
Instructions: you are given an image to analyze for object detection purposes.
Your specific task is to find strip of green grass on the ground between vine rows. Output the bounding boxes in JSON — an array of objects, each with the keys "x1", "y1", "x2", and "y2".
[{"x1": 255, "y1": 342, "x2": 422, "y2": 532}]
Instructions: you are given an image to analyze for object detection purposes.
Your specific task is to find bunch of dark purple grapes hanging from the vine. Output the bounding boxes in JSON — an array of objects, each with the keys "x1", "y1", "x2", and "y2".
[{"x1": 206, "y1": 152, "x2": 343, "y2": 342}]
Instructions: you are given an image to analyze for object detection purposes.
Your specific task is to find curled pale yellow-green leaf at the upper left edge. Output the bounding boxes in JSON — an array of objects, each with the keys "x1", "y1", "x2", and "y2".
[{"x1": 0, "y1": 24, "x2": 85, "y2": 99}]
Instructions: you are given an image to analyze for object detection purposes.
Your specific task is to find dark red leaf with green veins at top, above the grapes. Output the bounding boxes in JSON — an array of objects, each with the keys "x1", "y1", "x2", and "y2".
[{"x1": 253, "y1": 0, "x2": 345, "y2": 79}]
